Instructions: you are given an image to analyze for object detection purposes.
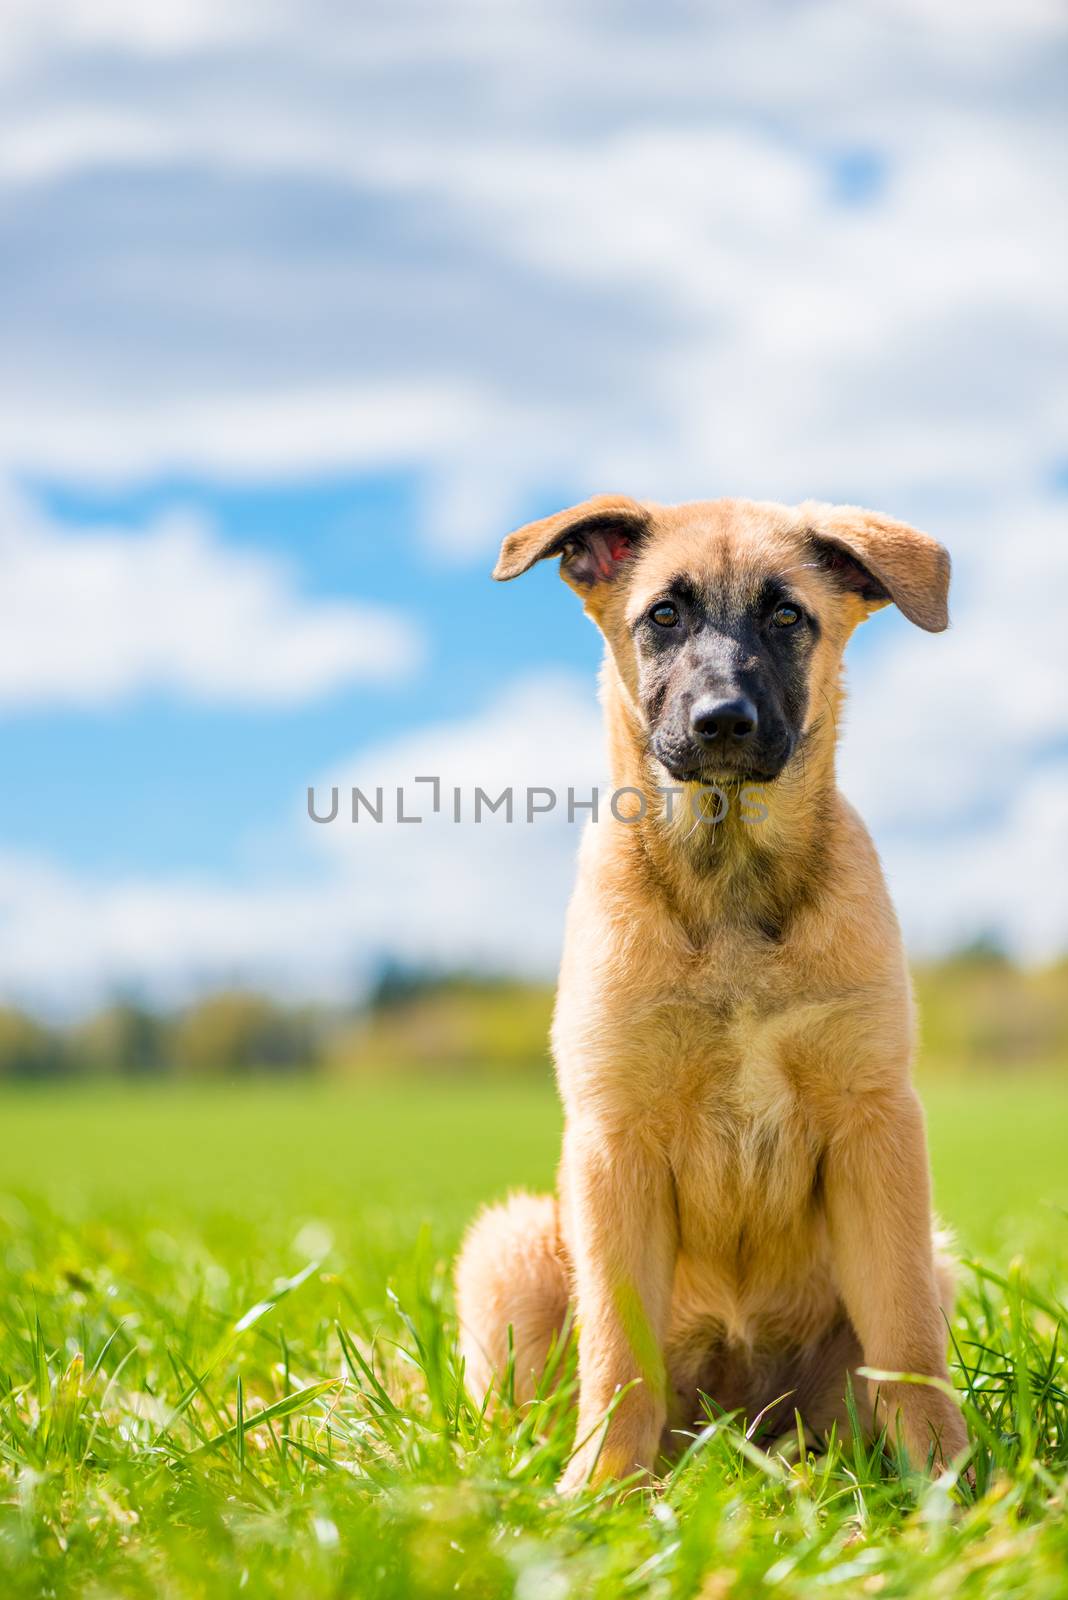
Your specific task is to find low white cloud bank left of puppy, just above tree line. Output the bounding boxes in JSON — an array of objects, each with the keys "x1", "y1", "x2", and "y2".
[{"x1": 0, "y1": 675, "x2": 604, "y2": 1011}]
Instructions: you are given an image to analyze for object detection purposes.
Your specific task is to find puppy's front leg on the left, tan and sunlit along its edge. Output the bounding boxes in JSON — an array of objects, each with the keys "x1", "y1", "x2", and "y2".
[{"x1": 560, "y1": 1125, "x2": 676, "y2": 1491}]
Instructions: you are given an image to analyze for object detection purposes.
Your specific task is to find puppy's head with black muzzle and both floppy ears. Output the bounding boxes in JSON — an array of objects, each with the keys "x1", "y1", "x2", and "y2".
[{"x1": 494, "y1": 494, "x2": 950, "y2": 782}]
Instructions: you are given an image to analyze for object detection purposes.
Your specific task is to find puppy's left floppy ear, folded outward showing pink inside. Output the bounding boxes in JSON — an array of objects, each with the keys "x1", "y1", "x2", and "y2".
[{"x1": 492, "y1": 494, "x2": 649, "y2": 590}]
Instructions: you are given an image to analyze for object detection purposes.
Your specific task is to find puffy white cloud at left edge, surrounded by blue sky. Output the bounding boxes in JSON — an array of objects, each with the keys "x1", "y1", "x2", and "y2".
[{"x1": 0, "y1": 502, "x2": 420, "y2": 709}]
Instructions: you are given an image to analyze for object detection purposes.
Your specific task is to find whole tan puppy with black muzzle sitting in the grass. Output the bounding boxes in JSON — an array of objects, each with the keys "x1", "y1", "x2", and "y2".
[{"x1": 457, "y1": 496, "x2": 966, "y2": 1488}]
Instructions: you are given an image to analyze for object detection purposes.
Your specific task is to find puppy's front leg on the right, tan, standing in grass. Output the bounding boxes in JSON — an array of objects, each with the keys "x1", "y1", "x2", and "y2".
[{"x1": 825, "y1": 1088, "x2": 967, "y2": 1467}]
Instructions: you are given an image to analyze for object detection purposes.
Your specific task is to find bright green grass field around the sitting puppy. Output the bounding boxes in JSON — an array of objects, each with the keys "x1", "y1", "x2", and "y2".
[{"x1": 0, "y1": 1077, "x2": 1068, "y2": 1600}]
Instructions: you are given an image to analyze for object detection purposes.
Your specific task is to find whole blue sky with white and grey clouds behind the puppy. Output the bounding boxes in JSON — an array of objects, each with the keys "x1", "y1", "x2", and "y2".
[{"x1": 0, "y1": 0, "x2": 1068, "y2": 1010}]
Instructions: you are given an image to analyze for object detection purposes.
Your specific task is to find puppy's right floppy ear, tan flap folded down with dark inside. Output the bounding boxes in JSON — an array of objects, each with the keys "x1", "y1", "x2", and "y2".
[{"x1": 801, "y1": 502, "x2": 950, "y2": 634}]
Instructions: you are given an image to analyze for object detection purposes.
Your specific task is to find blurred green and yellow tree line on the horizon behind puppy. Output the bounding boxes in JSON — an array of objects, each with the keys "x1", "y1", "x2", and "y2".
[{"x1": 0, "y1": 941, "x2": 1068, "y2": 1082}]
